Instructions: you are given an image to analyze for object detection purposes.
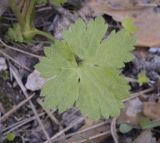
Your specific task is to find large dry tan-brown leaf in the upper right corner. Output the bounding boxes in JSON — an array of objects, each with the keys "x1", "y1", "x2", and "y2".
[{"x1": 80, "y1": 0, "x2": 160, "y2": 47}]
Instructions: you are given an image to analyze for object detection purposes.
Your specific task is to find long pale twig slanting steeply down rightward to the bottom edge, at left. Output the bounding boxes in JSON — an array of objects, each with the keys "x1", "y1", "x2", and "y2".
[{"x1": 10, "y1": 65, "x2": 52, "y2": 143}]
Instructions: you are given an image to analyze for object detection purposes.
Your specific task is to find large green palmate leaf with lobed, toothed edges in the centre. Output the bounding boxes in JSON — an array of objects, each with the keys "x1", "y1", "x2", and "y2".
[{"x1": 36, "y1": 17, "x2": 135, "y2": 119}]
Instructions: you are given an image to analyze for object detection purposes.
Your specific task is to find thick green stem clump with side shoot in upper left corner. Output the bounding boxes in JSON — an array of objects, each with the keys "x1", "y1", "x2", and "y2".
[{"x1": 7, "y1": 0, "x2": 64, "y2": 42}]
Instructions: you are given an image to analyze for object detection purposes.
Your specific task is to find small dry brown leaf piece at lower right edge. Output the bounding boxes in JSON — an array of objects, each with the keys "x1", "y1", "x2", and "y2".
[{"x1": 143, "y1": 101, "x2": 160, "y2": 120}]
